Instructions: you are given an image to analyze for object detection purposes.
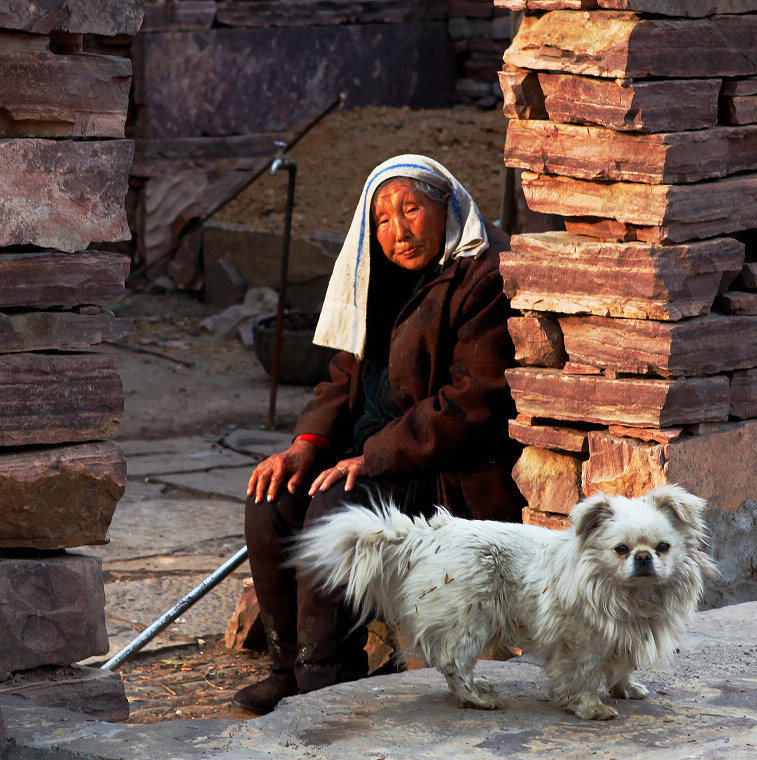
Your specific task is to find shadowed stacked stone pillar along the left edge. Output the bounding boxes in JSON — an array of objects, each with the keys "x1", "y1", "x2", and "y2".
[{"x1": 0, "y1": 0, "x2": 142, "y2": 718}]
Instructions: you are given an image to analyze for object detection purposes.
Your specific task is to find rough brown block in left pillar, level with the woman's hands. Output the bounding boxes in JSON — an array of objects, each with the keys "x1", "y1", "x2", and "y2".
[{"x1": 0, "y1": 441, "x2": 126, "y2": 550}]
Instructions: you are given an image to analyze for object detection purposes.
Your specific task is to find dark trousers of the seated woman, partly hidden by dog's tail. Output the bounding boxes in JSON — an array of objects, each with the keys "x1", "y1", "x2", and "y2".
[{"x1": 245, "y1": 467, "x2": 384, "y2": 692}]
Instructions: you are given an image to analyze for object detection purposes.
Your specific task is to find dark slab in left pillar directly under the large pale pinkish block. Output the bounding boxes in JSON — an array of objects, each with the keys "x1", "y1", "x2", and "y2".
[{"x1": 0, "y1": 251, "x2": 131, "y2": 308}]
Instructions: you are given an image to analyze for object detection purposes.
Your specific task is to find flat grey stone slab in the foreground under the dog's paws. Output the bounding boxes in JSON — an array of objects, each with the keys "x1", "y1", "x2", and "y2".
[{"x1": 0, "y1": 602, "x2": 757, "y2": 760}]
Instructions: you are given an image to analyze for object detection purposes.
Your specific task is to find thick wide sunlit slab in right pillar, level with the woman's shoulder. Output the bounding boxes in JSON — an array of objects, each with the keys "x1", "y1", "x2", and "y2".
[{"x1": 500, "y1": 229, "x2": 744, "y2": 320}]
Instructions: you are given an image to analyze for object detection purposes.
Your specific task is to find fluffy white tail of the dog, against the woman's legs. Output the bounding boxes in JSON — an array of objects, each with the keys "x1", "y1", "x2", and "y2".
[{"x1": 293, "y1": 502, "x2": 442, "y2": 622}]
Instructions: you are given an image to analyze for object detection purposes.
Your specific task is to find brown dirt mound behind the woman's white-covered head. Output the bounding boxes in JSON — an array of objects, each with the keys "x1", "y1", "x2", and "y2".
[{"x1": 216, "y1": 102, "x2": 507, "y2": 235}]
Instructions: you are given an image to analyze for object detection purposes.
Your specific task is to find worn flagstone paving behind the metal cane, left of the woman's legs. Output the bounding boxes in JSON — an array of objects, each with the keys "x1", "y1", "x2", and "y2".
[{"x1": 84, "y1": 428, "x2": 291, "y2": 665}]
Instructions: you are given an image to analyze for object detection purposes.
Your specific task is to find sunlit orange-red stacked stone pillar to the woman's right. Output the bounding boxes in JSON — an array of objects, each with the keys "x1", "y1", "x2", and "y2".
[{"x1": 495, "y1": 0, "x2": 757, "y2": 527}]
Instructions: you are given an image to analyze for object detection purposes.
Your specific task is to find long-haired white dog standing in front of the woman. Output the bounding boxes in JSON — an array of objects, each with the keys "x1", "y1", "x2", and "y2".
[{"x1": 295, "y1": 486, "x2": 717, "y2": 720}]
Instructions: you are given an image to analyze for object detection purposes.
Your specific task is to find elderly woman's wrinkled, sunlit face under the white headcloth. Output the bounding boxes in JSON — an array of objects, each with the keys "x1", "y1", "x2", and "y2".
[{"x1": 373, "y1": 179, "x2": 447, "y2": 272}]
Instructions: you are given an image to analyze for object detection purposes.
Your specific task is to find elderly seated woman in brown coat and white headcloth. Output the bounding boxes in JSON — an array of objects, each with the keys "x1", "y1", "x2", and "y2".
[{"x1": 234, "y1": 155, "x2": 521, "y2": 714}]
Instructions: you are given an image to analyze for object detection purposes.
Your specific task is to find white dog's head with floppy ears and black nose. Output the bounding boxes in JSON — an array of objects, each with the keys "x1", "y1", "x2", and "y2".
[{"x1": 571, "y1": 486, "x2": 705, "y2": 585}]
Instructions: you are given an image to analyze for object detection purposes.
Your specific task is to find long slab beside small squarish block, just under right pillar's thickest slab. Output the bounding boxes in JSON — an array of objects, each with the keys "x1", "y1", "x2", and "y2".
[{"x1": 560, "y1": 314, "x2": 757, "y2": 377}]
